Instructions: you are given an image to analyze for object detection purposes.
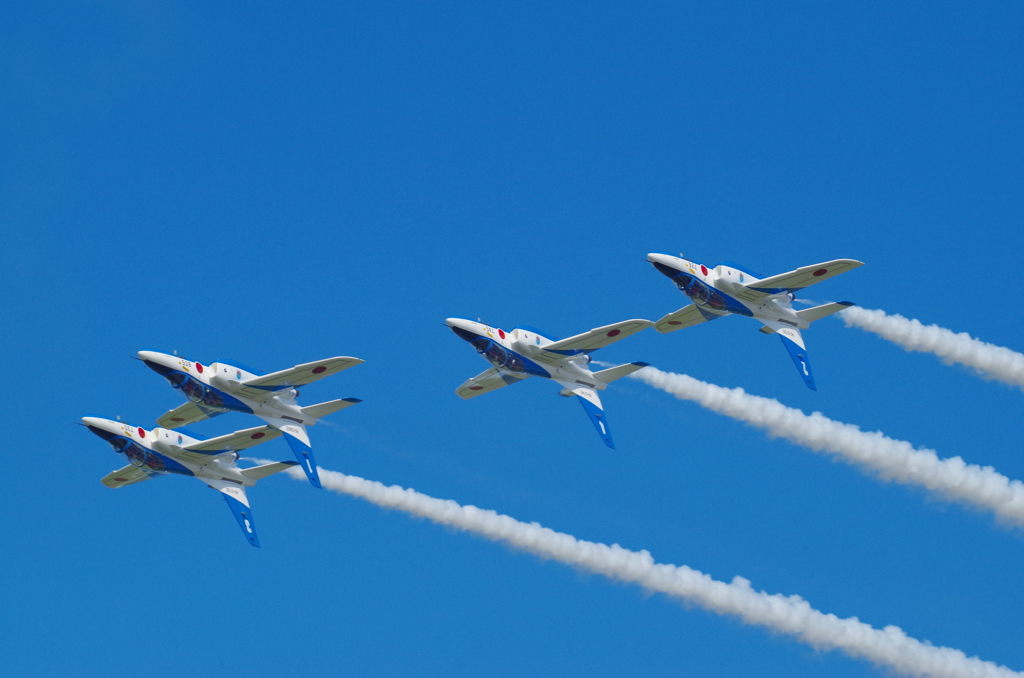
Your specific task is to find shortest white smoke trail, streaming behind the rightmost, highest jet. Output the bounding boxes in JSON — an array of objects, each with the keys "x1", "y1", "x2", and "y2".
[{"x1": 840, "y1": 306, "x2": 1024, "y2": 388}]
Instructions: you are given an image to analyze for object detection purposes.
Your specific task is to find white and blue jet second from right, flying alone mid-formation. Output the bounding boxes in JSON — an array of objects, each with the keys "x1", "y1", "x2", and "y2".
[{"x1": 445, "y1": 317, "x2": 652, "y2": 449}]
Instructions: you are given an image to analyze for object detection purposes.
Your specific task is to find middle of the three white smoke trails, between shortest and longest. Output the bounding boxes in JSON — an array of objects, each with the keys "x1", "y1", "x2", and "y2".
[{"x1": 630, "y1": 368, "x2": 1024, "y2": 526}]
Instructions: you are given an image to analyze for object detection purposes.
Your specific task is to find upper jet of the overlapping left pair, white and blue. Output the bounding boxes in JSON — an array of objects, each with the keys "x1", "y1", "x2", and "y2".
[{"x1": 138, "y1": 351, "x2": 362, "y2": 488}]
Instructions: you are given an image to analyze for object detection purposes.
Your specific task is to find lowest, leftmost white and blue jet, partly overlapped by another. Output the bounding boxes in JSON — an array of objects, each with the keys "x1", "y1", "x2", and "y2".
[{"x1": 82, "y1": 417, "x2": 298, "y2": 547}]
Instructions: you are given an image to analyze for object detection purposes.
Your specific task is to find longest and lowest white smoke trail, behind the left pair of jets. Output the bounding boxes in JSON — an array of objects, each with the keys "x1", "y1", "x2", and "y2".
[{"x1": 270, "y1": 468, "x2": 1024, "y2": 678}]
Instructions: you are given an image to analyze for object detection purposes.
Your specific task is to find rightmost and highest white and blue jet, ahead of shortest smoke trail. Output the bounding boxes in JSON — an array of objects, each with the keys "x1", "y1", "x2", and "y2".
[{"x1": 647, "y1": 253, "x2": 863, "y2": 390}]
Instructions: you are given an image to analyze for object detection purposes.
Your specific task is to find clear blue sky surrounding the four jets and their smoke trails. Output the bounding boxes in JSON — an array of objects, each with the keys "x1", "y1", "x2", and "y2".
[{"x1": 0, "y1": 1, "x2": 1024, "y2": 677}]
